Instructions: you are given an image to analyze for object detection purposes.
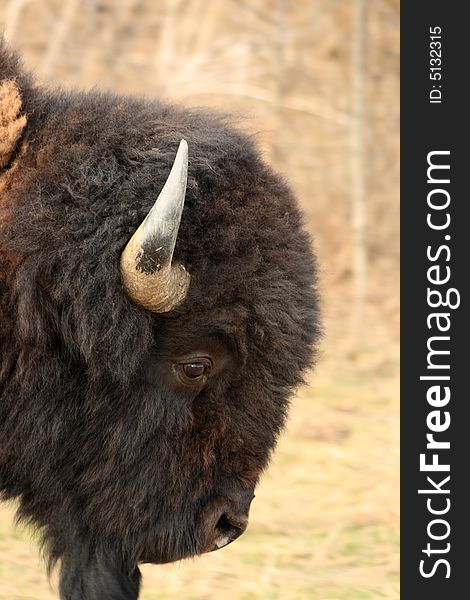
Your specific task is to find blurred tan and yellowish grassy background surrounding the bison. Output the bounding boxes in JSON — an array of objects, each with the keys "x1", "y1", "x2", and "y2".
[{"x1": 0, "y1": 0, "x2": 399, "y2": 600}]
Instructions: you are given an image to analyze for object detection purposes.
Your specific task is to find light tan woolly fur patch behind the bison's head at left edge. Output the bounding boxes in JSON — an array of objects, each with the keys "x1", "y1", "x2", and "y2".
[{"x1": 0, "y1": 79, "x2": 26, "y2": 169}]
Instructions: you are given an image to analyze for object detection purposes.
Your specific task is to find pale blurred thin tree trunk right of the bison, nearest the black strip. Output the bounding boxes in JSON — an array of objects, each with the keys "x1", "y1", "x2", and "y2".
[{"x1": 350, "y1": 0, "x2": 367, "y2": 348}]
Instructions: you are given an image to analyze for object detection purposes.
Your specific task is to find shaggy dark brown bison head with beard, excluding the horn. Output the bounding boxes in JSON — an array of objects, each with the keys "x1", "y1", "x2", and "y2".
[{"x1": 0, "y1": 42, "x2": 319, "y2": 600}]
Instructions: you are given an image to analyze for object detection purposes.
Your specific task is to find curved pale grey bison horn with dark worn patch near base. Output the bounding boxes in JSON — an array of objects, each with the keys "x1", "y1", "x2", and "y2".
[{"x1": 121, "y1": 140, "x2": 190, "y2": 313}]
